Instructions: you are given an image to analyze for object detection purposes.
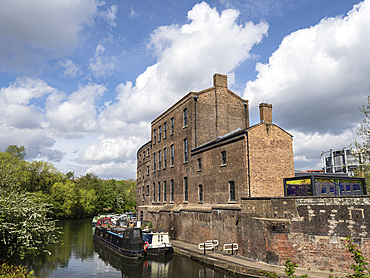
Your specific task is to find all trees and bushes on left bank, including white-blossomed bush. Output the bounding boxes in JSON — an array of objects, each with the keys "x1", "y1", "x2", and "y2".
[{"x1": 0, "y1": 145, "x2": 136, "y2": 261}]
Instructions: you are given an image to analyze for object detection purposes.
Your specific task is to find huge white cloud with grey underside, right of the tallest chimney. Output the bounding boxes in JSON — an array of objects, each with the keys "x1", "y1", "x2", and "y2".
[{"x1": 244, "y1": 0, "x2": 370, "y2": 134}]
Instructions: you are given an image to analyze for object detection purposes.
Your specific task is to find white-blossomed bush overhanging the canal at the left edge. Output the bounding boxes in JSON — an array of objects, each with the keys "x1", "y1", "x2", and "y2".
[{"x1": 0, "y1": 190, "x2": 58, "y2": 260}]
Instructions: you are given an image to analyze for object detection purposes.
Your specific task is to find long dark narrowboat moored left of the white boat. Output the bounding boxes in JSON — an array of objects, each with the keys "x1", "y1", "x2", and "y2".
[{"x1": 93, "y1": 226, "x2": 145, "y2": 259}]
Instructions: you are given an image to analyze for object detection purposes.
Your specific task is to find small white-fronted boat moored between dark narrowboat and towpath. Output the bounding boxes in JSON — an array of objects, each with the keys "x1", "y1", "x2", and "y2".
[{"x1": 143, "y1": 230, "x2": 173, "y2": 255}]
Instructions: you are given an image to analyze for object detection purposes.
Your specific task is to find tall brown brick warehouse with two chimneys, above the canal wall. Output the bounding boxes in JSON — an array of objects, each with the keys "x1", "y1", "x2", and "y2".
[{"x1": 137, "y1": 74, "x2": 294, "y2": 220}]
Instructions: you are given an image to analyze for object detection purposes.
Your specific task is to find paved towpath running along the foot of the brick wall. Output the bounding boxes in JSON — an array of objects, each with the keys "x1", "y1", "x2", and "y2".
[{"x1": 171, "y1": 240, "x2": 344, "y2": 278}]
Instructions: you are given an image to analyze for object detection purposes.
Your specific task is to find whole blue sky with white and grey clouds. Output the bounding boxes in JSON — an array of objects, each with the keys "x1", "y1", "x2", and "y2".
[{"x1": 0, "y1": 0, "x2": 370, "y2": 179}]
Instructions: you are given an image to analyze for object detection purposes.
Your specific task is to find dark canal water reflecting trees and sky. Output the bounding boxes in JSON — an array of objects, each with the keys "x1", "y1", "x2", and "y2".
[{"x1": 27, "y1": 219, "x2": 246, "y2": 278}]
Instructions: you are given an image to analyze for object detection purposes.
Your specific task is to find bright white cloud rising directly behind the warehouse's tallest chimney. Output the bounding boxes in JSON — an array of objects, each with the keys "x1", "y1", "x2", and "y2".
[{"x1": 102, "y1": 2, "x2": 268, "y2": 126}]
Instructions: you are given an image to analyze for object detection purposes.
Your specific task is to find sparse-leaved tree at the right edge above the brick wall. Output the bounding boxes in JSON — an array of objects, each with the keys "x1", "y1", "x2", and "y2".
[{"x1": 352, "y1": 95, "x2": 370, "y2": 191}]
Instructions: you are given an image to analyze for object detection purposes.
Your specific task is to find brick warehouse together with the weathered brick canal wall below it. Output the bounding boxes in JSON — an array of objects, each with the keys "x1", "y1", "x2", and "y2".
[{"x1": 137, "y1": 74, "x2": 370, "y2": 271}]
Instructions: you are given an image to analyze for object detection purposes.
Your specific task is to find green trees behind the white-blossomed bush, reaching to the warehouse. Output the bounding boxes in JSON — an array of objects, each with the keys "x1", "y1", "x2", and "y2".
[{"x1": 0, "y1": 145, "x2": 136, "y2": 219}]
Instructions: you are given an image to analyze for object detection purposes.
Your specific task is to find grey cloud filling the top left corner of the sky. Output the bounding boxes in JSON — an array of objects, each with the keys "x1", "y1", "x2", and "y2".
[{"x1": 0, "y1": 0, "x2": 97, "y2": 71}]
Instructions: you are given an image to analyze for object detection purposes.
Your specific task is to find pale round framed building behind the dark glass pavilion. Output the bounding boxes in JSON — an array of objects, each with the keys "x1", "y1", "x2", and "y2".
[{"x1": 321, "y1": 148, "x2": 360, "y2": 177}]
